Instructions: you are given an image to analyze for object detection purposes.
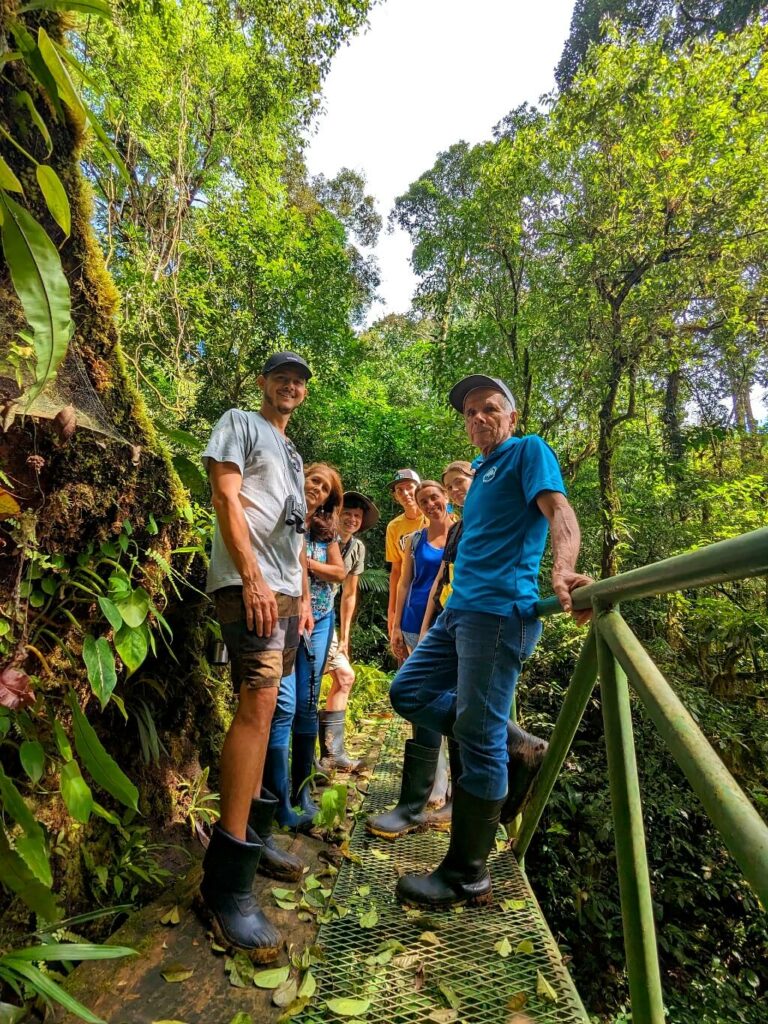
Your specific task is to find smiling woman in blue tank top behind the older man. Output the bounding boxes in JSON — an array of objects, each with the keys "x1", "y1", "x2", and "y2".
[{"x1": 392, "y1": 480, "x2": 454, "y2": 657}]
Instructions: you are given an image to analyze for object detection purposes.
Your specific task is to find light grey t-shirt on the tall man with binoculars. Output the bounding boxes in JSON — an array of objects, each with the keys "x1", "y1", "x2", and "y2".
[{"x1": 202, "y1": 409, "x2": 305, "y2": 597}]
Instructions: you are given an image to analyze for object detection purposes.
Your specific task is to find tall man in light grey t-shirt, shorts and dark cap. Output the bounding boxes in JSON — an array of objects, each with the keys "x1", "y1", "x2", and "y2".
[{"x1": 199, "y1": 352, "x2": 312, "y2": 963}]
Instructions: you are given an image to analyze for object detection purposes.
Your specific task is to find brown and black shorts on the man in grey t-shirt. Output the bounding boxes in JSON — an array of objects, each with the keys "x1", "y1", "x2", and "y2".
[{"x1": 213, "y1": 587, "x2": 300, "y2": 693}]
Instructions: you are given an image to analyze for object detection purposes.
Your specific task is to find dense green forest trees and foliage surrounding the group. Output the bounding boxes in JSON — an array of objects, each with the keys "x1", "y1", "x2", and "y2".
[{"x1": 0, "y1": 0, "x2": 768, "y2": 1024}]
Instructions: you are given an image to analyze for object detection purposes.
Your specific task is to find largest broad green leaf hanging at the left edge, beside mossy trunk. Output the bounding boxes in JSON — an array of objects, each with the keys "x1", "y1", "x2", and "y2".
[{"x1": 0, "y1": 192, "x2": 74, "y2": 403}]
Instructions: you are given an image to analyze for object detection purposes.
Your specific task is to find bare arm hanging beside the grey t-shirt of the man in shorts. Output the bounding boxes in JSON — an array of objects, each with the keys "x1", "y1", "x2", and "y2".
[{"x1": 208, "y1": 460, "x2": 278, "y2": 637}]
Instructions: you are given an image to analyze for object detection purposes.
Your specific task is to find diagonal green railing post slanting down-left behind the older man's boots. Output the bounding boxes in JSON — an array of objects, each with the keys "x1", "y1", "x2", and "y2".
[{"x1": 514, "y1": 627, "x2": 597, "y2": 861}]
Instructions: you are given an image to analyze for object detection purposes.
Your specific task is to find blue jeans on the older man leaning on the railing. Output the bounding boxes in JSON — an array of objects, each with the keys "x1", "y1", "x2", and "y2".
[{"x1": 389, "y1": 606, "x2": 542, "y2": 800}]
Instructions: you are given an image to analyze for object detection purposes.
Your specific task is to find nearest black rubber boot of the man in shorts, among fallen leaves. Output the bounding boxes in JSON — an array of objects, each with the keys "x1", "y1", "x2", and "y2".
[{"x1": 197, "y1": 822, "x2": 283, "y2": 964}]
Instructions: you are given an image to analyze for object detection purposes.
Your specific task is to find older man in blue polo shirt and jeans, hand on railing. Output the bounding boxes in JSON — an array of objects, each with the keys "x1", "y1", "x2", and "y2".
[{"x1": 391, "y1": 374, "x2": 591, "y2": 908}]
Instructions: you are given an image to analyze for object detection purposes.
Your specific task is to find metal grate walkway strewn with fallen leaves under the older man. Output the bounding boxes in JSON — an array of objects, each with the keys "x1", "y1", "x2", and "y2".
[{"x1": 295, "y1": 721, "x2": 589, "y2": 1024}]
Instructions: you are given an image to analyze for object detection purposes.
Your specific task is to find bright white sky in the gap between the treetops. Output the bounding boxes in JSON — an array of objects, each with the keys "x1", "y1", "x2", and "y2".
[{"x1": 306, "y1": 0, "x2": 573, "y2": 321}]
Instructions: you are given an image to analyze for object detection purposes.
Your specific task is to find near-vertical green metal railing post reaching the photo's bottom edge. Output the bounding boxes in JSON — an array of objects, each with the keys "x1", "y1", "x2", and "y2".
[{"x1": 595, "y1": 608, "x2": 665, "y2": 1024}]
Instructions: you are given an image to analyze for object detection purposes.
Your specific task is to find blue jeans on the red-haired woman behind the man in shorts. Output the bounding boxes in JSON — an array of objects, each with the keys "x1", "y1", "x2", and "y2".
[{"x1": 269, "y1": 609, "x2": 334, "y2": 749}]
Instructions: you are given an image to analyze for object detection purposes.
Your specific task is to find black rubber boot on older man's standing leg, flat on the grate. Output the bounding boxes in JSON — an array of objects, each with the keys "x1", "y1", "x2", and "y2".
[{"x1": 395, "y1": 785, "x2": 504, "y2": 910}]
